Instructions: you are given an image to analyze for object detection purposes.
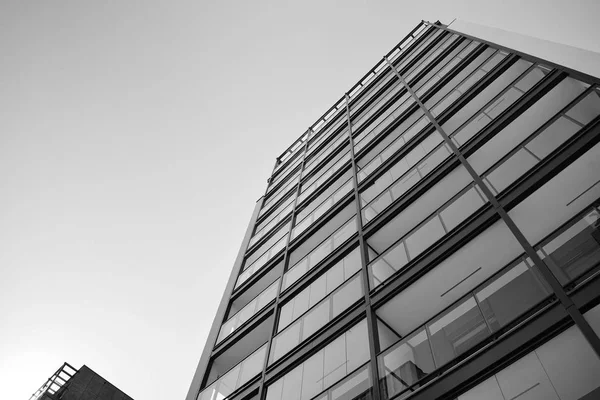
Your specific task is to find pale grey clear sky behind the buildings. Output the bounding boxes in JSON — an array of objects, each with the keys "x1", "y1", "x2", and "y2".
[{"x1": 0, "y1": 0, "x2": 600, "y2": 400}]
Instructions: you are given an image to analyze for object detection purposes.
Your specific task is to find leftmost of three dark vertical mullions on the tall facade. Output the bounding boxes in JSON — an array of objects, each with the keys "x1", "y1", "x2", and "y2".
[{"x1": 258, "y1": 128, "x2": 313, "y2": 399}]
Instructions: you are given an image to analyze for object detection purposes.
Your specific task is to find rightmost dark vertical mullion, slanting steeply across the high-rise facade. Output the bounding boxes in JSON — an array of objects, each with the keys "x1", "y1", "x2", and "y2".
[{"x1": 384, "y1": 34, "x2": 600, "y2": 357}]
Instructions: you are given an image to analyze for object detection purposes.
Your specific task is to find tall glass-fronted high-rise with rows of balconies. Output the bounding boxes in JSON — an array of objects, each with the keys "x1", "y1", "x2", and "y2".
[{"x1": 187, "y1": 21, "x2": 600, "y2": 400}]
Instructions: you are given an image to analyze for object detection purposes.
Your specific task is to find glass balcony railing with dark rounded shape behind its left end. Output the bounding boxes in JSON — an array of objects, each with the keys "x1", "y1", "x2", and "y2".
[{"x1": 377, "y1": 256, "x2": 551, "y2": 398}]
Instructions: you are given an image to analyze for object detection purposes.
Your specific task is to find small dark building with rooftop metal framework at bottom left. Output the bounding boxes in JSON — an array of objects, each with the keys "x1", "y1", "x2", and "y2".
[{"x1": 29, "y1": 363, "x2": 132, "y2": 400}]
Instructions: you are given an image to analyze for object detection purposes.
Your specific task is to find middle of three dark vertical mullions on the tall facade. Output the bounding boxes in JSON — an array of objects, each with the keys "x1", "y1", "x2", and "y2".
[{"x1": 346, "y1": 93, "x2": 381, "y2": 400}]
